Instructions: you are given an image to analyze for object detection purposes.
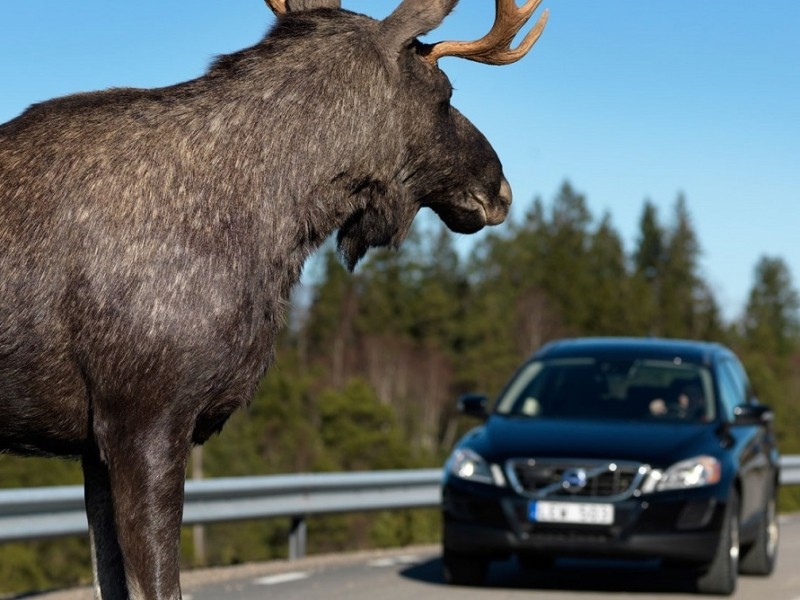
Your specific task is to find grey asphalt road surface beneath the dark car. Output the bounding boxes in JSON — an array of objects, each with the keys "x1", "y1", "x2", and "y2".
[{"x1": 37, "y1": 515, "x2": 800, "y2": 600}]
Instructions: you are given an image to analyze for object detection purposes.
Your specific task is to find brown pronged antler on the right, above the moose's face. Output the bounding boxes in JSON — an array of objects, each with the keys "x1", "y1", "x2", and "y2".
[{"x1": 423, "y1": 0, "x2": 549, "y2": 65}]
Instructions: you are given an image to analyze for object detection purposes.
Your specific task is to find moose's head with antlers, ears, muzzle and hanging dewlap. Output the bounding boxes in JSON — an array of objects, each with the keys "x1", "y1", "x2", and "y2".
[{"x1": 260, "y1": 0, "x2": 547, "y2": 268}]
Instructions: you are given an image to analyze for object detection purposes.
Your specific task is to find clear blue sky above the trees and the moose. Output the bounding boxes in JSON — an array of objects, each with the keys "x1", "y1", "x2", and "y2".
[{"x1": 0, "y1": 0, "x2": 800, "y2": 318}]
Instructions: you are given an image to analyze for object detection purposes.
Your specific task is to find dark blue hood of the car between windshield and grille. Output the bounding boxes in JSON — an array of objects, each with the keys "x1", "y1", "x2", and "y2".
[{"x1": 461, "y1": 415, "x2": 720, "y2": 467}]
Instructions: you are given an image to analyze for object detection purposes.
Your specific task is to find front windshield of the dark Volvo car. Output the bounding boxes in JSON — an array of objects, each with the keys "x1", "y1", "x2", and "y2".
[{"x1": 495, "y1": 358, "x2": 715, "y2": 423}]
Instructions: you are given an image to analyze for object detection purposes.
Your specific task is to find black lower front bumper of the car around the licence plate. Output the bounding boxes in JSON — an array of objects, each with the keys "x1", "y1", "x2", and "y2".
[{"x1": 443, "y1": 482, "x2": 725, "y2": 565}]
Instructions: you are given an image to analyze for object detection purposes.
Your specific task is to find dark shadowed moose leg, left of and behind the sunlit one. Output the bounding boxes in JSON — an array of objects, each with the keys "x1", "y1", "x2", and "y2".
[{"x1": 83, "y1": 448, "x2": 128, "y2": 600}]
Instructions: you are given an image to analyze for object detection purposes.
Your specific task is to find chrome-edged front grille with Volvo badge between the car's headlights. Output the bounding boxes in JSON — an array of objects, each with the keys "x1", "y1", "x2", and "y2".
[{"x1": 506, "y1": 459, "x2": 647, "y2": 499}]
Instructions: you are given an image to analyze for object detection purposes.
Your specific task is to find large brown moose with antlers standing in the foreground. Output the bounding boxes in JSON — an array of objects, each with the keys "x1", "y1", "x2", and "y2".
[{"x1": 0, "y1": 0, "x2": 547, "y2": 600}]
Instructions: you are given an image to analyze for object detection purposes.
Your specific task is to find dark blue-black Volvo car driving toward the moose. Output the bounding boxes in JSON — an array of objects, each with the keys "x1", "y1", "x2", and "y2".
[{"x1": 442, "y1": 338, "x2": 779, "y2": 595}]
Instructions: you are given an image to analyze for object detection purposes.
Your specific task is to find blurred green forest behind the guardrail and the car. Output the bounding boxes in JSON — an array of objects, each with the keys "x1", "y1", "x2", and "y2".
[{"x1": 0, "y1": 182, "x2": 800, "y2": 594}]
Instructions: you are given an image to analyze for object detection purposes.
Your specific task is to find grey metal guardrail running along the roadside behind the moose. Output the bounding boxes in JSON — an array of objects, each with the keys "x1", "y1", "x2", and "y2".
[{"x1": 0, "y1": 455, "x2": 800, "y2": 558}]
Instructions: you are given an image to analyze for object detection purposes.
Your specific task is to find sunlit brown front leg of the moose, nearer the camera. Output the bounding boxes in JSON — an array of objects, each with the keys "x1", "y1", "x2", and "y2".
[{"x1": 96, "y1": 431, "x2": 190, "y2": 600}]
